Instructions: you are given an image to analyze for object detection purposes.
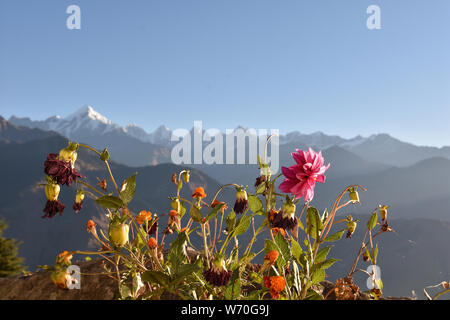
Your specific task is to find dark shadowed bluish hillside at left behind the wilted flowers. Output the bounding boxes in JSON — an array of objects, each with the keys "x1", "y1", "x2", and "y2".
[{"x1": 0, "y1": 131, "x2": 230, "y2": 270}]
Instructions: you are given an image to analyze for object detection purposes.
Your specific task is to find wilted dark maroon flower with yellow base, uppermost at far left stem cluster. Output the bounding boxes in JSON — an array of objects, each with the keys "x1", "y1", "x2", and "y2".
[{"x1": 44, "y1": 149, "x2": 84, "y2": 186}]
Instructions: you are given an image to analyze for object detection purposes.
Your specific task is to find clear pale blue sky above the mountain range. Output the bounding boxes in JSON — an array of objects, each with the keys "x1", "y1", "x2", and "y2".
[{"x1": 0, "y1": 0, "x2": 450, "y2": 146}]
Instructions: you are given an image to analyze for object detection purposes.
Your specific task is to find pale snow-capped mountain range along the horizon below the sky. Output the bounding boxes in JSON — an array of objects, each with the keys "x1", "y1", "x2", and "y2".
[{"x1": 9, "y1": 105, "x2": 450, "y2": 167}]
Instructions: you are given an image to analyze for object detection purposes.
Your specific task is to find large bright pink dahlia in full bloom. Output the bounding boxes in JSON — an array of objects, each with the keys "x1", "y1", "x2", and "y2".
[{"x1": 279, "y1": 148, "x2": 330, "y2": 201}]
